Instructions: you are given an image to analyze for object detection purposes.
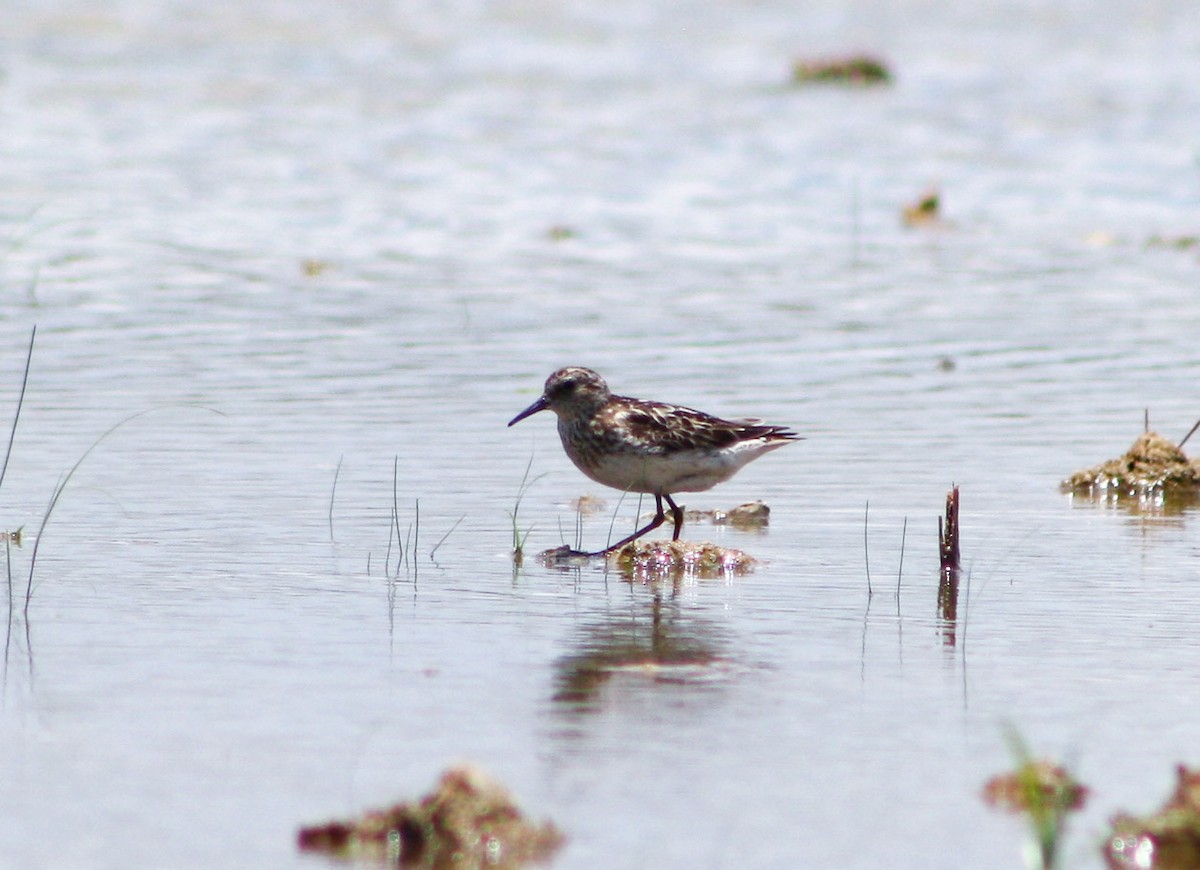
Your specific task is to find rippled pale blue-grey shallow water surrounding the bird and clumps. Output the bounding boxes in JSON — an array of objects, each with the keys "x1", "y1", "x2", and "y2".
[{"x1": 0, "y1": 0, "x2": 1200, "y2": 868}]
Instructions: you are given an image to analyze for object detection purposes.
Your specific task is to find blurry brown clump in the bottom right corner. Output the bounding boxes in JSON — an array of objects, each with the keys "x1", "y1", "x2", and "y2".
[{"x1": 1104, "y1": 764, "x2": 1200, "y2": 870}]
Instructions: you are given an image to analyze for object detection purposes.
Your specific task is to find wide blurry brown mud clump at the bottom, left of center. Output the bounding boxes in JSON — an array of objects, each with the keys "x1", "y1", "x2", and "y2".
[{"x1": 298, "y1": 764, "x2": 564, "y2": 870}]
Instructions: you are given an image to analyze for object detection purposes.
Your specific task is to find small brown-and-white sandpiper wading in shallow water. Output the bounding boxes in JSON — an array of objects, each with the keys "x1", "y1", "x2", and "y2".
[{"x1": 509, "y1": 366, "x2": 799, "y2": 556}]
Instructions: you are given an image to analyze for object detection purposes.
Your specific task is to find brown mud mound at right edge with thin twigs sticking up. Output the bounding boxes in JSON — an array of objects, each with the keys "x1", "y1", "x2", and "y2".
[{"x1": 1062, "y1": 432, "x2": 1200, "y2": 496}]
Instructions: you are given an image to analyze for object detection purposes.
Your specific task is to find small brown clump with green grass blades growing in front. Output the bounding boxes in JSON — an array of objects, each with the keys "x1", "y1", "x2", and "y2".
[{"x1": 983, "y1": 732, "x2": 1087, "y2": 870}]
